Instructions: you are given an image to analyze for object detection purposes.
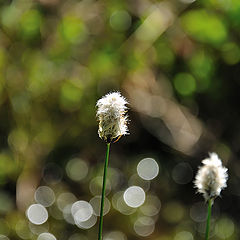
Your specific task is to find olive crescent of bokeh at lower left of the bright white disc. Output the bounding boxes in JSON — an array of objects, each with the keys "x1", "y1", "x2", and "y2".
[{"x1": 112, "y1": 191, "x2": 136, "y2": 215}]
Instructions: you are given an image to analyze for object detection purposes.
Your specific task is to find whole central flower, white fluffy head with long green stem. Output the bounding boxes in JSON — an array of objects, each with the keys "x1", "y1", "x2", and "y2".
[{"x1": 96, "y1": 92, "x2": 128, "y2": 240}]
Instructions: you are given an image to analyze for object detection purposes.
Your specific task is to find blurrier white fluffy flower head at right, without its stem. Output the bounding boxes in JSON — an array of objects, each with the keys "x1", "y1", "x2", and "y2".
[{"x1": 194, "y1": 153, "x2": 228, "y2": 201}]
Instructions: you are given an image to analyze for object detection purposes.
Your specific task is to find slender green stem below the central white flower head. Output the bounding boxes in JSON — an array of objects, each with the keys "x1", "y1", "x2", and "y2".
[{"x1": 98, "y1": 143, "x2": 110, "y2": 240}]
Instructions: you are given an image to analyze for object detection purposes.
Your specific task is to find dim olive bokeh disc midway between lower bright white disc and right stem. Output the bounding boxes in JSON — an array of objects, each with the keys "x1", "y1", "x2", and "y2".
[{"x1": 162, "y1": 201, "x2": 185, "y2": 223}]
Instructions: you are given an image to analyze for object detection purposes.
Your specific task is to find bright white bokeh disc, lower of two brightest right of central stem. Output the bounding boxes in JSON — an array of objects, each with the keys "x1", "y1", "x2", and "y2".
[{"x1": 123, "y1": 186, "x2": 145, "y2": 208}]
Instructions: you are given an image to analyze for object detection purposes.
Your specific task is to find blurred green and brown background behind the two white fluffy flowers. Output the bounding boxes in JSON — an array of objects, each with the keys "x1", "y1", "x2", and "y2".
[{"x1": 0, "y1": 0, "x2": 240, "y2": 240}]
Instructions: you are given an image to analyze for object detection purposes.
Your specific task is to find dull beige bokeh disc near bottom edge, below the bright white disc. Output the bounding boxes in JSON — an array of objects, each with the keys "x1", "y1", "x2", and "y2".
[{"x1": 134, "y1": 217, "x2": 155, "y2": 237}]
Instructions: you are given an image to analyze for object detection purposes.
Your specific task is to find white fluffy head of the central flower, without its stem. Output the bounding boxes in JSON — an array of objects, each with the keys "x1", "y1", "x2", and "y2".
[{"x1": 96, "y1": 92, "x2": 128, "y2": 143}]
